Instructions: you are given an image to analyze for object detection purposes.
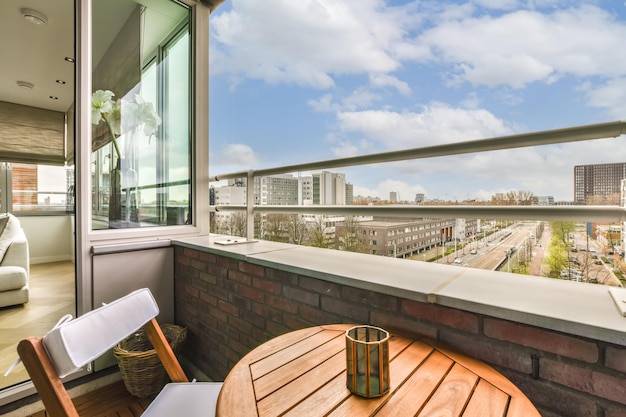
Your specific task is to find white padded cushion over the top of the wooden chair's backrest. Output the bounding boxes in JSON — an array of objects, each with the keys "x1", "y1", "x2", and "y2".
[{"x1": 43, "y1": 288, "x2": 159, "y2": 378}]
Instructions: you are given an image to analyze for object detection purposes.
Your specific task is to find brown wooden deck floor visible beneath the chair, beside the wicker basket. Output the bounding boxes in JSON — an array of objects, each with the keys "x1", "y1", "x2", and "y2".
[{"x1": 27, "y1": 381, "x2": 151, "y2": 417}]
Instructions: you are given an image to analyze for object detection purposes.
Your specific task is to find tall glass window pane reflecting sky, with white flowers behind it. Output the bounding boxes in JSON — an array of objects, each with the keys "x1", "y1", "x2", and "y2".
[{"x1": 92, "y1": 0, "x2": 192, "y2": 229}]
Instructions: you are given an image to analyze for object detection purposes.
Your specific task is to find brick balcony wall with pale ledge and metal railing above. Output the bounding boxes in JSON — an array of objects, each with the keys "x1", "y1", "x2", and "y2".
[{"x1": 174, "y1": 118, "x2": 626, "y2": 417}]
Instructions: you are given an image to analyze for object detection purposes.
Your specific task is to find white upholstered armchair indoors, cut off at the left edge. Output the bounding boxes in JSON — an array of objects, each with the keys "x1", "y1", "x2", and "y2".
[{"x1": 0, "y1": 218, "x2": 30, "y2": 307}]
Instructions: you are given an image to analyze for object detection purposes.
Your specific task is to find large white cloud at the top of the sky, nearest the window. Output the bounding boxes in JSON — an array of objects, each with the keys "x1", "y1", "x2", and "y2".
[{"x1": 211, "y1": 0, "x2": 419, "y2": 90}]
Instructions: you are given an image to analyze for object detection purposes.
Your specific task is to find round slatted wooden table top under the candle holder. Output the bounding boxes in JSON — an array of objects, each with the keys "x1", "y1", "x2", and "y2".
[{"x1": 216, "y1": 324, "x2": 541, "y2": 417}]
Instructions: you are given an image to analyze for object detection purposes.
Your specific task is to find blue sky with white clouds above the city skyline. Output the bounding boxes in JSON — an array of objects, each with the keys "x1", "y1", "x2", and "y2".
[{"x1": 210, "y1": 0, "x2": 626, "y2": 200}]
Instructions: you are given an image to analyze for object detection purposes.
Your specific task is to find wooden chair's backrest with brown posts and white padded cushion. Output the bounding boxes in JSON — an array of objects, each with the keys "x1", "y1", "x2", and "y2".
[{"x1": 17, "y1": 288, "x2": 188, "y2": 417}]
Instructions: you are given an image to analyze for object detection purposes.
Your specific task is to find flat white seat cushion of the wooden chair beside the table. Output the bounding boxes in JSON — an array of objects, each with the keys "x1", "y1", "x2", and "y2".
[{"x1": 141, "y1": 382, "x2": 223, "y2": 417}]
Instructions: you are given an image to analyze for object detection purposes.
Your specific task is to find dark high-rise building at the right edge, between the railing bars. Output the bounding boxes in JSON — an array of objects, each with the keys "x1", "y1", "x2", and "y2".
[{"x1": 574, "y1": 162, "x2": 626, "y2": 203}]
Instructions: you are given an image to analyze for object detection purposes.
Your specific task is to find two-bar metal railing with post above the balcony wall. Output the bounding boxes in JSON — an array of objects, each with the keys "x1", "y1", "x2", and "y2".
[{"x1": 209, "y1": 121, "x2": 626, "y2": 238}]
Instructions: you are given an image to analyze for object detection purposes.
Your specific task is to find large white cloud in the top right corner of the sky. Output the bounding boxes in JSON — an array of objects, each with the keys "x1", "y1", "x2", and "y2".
[{"x1": 418, "y1": 6, "x2": 626, "y2": 88}]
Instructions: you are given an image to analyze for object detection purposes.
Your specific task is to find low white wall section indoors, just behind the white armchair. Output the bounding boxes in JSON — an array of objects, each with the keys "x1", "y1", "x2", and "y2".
[{"x1": 19, "y1": 215, "x2": 74, "y2": 264}]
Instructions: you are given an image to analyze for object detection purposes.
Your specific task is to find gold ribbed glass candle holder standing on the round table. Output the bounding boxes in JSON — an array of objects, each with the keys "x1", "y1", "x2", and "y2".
[{"x1": 346, "y1": 326, "x2": 389, "y2": 398}]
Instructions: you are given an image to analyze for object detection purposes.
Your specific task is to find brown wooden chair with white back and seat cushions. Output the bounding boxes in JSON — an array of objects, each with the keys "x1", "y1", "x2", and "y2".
[{"x1": 17, "y1": 288, "x2": 222, "y2": 417}]
